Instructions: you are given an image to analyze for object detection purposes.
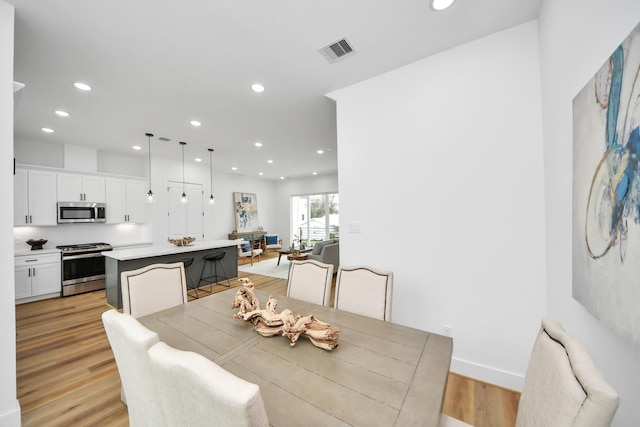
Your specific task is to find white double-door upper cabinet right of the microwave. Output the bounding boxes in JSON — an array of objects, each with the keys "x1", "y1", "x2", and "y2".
[{"x1": 106, "y1": 178, "x2": 147, "y2": 224}]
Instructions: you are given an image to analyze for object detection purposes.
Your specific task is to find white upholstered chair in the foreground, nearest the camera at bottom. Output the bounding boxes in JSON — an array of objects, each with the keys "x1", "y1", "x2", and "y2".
[{"x1": 149, "y1": 342, "x2": 269, "y2": 427}]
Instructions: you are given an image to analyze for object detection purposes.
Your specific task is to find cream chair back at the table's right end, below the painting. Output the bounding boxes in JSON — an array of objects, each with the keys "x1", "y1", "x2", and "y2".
[{"x1": 516, "y1": 319, "x2": 620, "y2": 427}]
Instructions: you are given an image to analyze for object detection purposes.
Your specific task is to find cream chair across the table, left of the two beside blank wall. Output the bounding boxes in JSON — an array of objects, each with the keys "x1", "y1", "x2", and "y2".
[{"x1": 287, "y1": 260, "x2": 333, "y2": 306}]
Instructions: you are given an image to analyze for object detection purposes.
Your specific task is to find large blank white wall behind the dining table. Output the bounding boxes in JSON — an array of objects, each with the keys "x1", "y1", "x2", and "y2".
[{"x1": 329, "y1": 22, "x2": 545, "y2": 389}]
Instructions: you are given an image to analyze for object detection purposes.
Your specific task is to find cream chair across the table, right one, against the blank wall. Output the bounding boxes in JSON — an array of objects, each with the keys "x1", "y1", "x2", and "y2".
[{"x1": 334, "y1": 266, "x2": 393, "y2": 322}]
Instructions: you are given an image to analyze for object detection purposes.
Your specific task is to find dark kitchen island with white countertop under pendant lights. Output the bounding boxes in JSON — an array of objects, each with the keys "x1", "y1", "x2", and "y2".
[{"x1": 102, "y1": 240, "x2": 238, "y2": 308}]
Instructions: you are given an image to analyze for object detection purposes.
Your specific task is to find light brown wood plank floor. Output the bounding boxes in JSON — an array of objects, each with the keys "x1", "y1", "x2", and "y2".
[{"x1": 16, "y1": 254, "x2": 519, "y2": 427}]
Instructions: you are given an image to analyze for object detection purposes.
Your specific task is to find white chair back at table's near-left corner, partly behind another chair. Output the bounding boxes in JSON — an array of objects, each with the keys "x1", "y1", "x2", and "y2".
[{"x1": 102, "y1": 310, "x2": 167, "y2": 427}]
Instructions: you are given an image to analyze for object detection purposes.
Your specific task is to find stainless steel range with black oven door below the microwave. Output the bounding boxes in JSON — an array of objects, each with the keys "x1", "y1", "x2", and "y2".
[{"x1": 56, "y1": 243, "x2": 113, "y2": 297}]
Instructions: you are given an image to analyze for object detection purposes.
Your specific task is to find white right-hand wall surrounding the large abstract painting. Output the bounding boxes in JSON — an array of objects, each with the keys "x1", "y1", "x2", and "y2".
[{"x1": 539, "y1": 0, "x2": 640, "y2": 426}]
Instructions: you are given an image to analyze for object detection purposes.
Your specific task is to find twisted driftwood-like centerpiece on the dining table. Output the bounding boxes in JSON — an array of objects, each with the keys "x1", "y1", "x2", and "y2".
[{"x1": 231, "y1": 277, "x2": 340, "y2": 350}]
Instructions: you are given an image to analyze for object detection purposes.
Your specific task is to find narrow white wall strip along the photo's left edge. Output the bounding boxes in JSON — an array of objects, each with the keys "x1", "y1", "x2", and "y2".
[{"x1": 0, "y1": 1, "x2": 20, "y2": 427}]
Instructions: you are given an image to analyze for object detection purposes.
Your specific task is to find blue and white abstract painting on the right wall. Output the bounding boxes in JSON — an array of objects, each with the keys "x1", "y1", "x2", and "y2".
[{"x1": 572, "y1": 21, "x2": 640, "y2": 349}]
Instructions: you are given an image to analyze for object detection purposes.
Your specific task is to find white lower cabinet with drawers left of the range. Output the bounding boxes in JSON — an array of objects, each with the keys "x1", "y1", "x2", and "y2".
[{"x1": 15, "y1": 253, "x2": 61, "y2": 302}]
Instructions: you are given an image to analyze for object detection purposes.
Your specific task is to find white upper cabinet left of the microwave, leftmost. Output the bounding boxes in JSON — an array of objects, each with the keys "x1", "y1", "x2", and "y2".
[{"x1": 13, "y1": 169, "x2": 57, "y2": 226}]
